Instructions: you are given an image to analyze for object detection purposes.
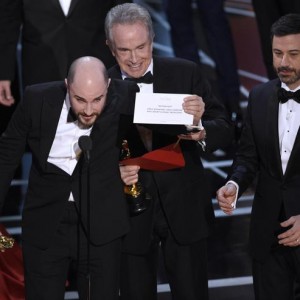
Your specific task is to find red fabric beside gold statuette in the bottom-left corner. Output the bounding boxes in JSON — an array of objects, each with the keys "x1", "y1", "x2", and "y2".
[{"x1": 0, "y1": 224, "x2": 25, "y2": 300}]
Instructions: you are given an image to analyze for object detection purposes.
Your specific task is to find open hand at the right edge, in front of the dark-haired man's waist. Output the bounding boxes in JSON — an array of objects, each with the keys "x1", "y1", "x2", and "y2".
[{"x1": 278, "y1": 215, "x2": 300, "y2": 247}]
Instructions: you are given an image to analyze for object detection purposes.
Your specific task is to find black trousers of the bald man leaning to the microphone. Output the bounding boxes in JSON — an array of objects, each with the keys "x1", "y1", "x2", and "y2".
[{"x1": 23, "y1": 203, "x2": 121, "y2": 300}]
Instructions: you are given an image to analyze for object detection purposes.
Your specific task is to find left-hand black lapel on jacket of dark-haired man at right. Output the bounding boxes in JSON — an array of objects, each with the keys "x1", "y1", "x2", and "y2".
[{"x1": 268, "y1": 85, "x2": 283, "y2": 177}]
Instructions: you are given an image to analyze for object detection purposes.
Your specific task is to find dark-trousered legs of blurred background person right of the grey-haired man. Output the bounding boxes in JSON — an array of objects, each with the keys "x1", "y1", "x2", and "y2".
[{"x1": 163, "y1": 0, "x2": 242, "y2": 127}]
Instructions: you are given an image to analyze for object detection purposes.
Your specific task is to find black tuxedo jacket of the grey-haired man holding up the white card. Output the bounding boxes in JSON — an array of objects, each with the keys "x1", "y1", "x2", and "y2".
[{"x1": 109, "y1": 57, "x2": 232, "y2": 253}]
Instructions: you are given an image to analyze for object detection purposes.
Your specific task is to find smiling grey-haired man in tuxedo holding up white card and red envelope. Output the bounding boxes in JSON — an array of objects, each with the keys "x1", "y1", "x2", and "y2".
[{"x1": 105, "y1": 3, "x2": 232, "y2": 300}]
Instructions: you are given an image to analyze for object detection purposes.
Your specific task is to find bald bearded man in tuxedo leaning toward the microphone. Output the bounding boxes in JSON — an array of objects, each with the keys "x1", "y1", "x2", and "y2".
[{"x1": 0, "y1": 57, "x2": 137, "y2": 300}]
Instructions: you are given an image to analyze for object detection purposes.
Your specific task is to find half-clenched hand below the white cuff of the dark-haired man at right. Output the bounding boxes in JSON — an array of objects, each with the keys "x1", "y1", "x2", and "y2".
[{"x1": 217, "y1": 183, "x2": 237, "y2": 215}]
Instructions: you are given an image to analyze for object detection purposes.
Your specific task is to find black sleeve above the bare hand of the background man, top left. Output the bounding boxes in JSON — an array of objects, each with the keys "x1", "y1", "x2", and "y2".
[{"x1": 0, "y1": 0, "x2": 22, "y2": 80}]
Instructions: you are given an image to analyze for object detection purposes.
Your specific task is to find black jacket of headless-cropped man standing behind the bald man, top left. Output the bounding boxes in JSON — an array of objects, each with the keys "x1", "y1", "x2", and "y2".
[{"x1": 0, "y1": 0, "x2": 130, "y2": 86}]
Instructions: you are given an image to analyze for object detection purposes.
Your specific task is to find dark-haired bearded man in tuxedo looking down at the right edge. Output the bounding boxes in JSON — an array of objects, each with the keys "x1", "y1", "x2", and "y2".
[{"x1": 217, "y1": 14, "x2": 300, "y2": 300}]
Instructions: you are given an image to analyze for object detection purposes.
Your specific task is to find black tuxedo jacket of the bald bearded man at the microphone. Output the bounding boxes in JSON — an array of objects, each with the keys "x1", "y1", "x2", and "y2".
[{"x1": 0, "y1": 80, "x2": 137, "y2": 248}]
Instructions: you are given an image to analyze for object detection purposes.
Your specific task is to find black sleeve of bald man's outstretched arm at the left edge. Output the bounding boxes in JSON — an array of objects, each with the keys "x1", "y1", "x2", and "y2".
[{"x1": 0, "y1": 85, "x2": 31, "y2": 210}]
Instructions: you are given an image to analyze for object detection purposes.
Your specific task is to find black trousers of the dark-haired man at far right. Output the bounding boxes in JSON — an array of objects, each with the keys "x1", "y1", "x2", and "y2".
[{"x1": 253, "y1": 246, "x2": 300, "y2": 300}]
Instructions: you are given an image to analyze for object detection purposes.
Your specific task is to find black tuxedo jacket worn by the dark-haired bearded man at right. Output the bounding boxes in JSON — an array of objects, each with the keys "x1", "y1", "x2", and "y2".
[{"x1": 230, "y1": 79, "x2": 300, "y2": 260}]
